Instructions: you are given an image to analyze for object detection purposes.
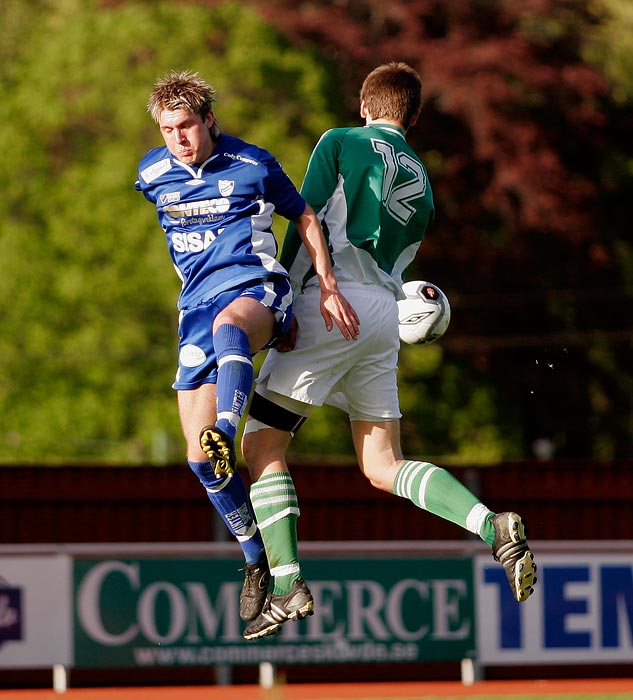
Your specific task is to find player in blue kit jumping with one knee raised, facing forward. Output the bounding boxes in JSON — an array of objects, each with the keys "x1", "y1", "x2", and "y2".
[{"x1": 136, "y1": 71, "x2": 358, "y2": 620}]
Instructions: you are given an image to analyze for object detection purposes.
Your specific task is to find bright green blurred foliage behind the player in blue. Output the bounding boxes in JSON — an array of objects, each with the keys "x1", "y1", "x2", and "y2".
[{"x1": 0, "y1": 0, "x2": 330, "y2": 463}]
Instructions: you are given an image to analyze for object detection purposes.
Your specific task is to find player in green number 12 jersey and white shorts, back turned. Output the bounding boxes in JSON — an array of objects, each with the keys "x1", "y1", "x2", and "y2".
[{"x1": 242, "y1": 63, "x2": 536, "y2": 639}]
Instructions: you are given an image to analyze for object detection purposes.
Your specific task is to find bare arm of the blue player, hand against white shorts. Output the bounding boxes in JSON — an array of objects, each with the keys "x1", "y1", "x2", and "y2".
[{"x1": 293, "y1": 204, "x2": 359, "y2": 340}]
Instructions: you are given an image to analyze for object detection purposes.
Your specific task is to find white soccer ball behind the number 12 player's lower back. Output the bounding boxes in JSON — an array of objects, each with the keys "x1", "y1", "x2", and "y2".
[{"x1": 398, "y1": 281, "x2": 451, "y2": 345}]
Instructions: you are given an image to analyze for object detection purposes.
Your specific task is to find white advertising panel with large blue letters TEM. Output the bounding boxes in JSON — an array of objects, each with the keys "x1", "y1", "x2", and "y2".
[{"x1": 475, "y1": 550, "x2": 633, "y2": 665}]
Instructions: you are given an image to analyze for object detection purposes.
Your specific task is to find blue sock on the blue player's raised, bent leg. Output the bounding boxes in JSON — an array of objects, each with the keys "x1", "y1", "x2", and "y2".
[{"x1": 213, "y1": 323, "x2": 254, "y2": 439}]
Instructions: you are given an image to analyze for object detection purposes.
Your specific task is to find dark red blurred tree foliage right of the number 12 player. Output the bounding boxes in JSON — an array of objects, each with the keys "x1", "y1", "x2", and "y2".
[{"x1": 247, "y1": 0, "x2": 633, "y2": 458}]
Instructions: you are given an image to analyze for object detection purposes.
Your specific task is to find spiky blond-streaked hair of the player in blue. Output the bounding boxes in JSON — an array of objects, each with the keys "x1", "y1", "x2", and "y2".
[{"x1": 147, "y1": 71, "x2": 220, "y2": 139}]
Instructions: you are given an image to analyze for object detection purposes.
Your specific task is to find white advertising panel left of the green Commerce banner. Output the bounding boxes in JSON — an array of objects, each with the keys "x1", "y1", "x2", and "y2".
[{"x1": 0, "y1": 555, "x2": 72, "y2": 668}]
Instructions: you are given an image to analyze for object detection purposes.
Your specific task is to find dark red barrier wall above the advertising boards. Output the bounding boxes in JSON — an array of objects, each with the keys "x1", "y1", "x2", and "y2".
[{"x1": 0, "y1": 461, "x2": 633, "y2": 544}]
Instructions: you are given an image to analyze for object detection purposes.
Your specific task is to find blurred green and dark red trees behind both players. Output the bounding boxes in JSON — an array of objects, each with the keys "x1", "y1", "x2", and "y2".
[{"x1": 0, "y1": 0, "x2": 633, "y2": 464}]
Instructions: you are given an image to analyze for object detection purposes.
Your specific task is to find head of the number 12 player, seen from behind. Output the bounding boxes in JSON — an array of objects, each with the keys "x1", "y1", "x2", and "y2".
[{"x1": 360, "y1": 61, "x2": 422, "y2": 129}]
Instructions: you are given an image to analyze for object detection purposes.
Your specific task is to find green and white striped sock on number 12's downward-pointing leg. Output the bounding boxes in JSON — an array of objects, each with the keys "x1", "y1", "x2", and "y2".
[{"x1": 251, "y1": 472, "x2": 301, "y2": 595}]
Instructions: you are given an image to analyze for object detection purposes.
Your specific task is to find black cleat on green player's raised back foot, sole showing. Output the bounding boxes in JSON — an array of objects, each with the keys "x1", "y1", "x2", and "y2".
[{"x1": 491, "y1": 513, "x2": 536, "y2": 603}]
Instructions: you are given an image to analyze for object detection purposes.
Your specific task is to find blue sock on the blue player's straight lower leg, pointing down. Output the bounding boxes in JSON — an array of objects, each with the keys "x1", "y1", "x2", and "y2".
[{"x1": 189, "y1": 461, "x2": 264, "y2": 564}]
